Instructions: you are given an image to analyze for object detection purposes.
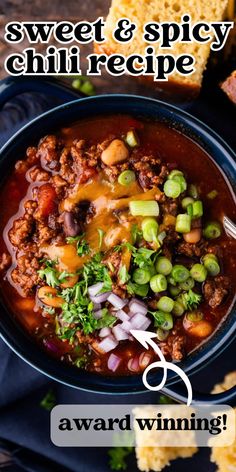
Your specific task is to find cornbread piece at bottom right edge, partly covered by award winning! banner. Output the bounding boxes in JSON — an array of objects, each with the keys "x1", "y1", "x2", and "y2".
[{"x1": 211, "y1": 371, "x2": 236, "y2": 472}]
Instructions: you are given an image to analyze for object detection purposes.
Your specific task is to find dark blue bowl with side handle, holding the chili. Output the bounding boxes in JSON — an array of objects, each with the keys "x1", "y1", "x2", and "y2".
[{"x1": 0, "y1": 79, "x2": 236, "y2": 403}]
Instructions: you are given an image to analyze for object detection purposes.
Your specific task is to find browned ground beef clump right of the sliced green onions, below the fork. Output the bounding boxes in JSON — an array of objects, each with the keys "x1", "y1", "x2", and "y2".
[{"x1": 203, "y1": 275, "x2": 230, "y2": 308}]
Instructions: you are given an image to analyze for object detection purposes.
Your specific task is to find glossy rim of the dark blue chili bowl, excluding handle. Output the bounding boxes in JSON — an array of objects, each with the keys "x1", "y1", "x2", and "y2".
[{"x1": 0, "y1": 94, "x2": 236, "y2": 394}]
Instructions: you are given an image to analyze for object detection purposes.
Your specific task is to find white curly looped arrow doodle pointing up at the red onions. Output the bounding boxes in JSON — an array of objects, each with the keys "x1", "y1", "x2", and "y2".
[{"x1": 130, "y1": 329, "x2": 193, "y2": 406}]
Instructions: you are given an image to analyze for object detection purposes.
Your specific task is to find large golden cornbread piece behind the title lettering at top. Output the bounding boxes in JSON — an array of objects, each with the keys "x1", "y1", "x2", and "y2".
[{"x1": 99, "y1": 0, "x2": 228, "y2": 96}]
